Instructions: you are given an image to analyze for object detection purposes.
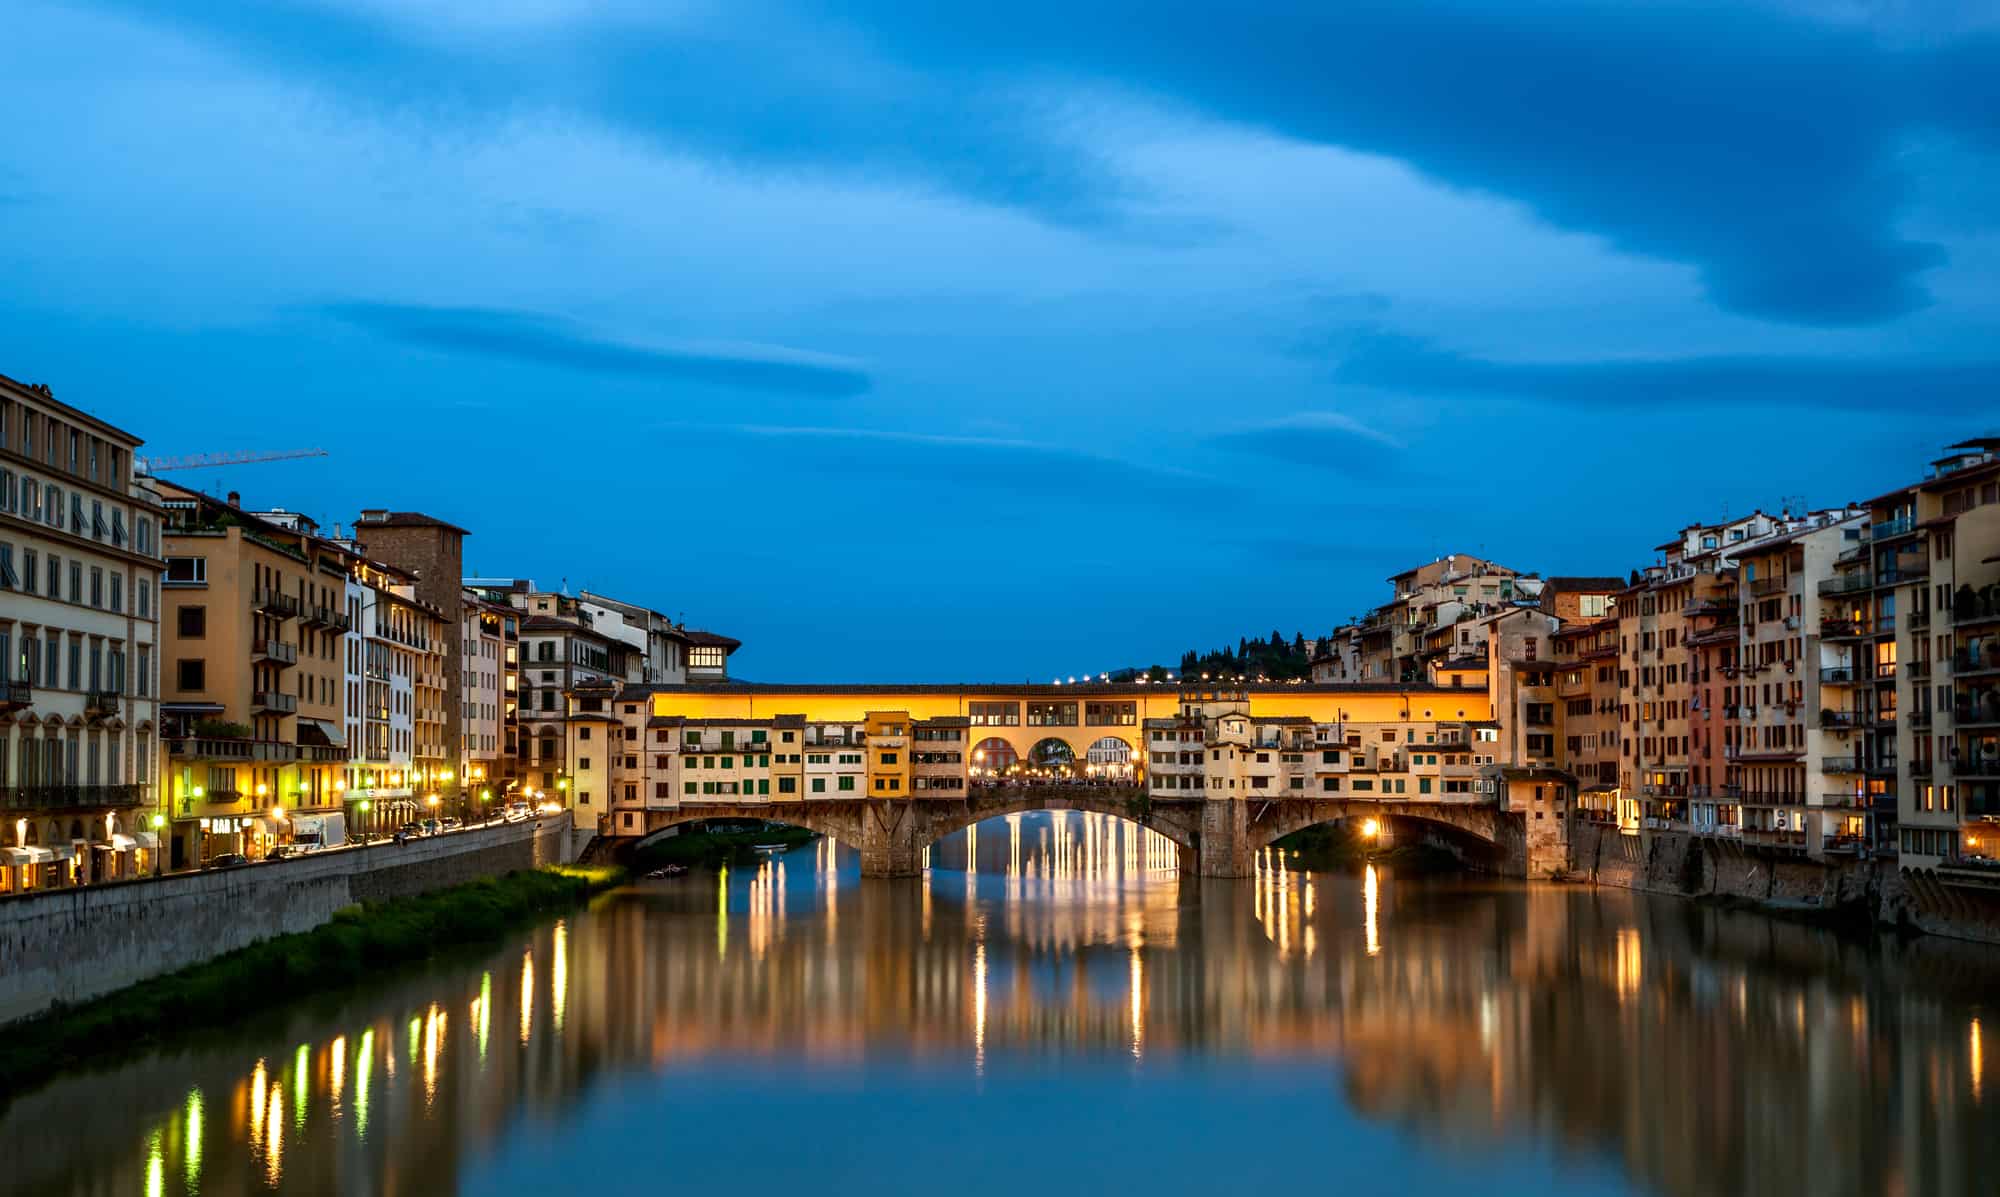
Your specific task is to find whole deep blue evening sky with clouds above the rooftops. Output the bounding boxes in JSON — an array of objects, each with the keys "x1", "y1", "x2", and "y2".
[{"x1": 0, "y1": 0, "x2": 2000, "y2": 681}]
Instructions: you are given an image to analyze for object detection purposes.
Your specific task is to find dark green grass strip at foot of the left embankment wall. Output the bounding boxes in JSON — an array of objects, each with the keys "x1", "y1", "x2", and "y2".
[{"x1": 0, "y1": 867, "x2": 624, "y2": 1107}]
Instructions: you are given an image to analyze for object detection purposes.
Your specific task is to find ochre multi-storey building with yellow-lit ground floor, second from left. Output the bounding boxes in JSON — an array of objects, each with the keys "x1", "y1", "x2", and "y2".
[{"x1": 158, "y1": 482, "x2": 356, "y2": 869}]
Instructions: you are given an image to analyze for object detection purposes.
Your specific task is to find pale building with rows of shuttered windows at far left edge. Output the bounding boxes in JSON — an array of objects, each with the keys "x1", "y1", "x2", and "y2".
[{"x1": 0, "y1": 376, "x2": 162, "y2": 893}]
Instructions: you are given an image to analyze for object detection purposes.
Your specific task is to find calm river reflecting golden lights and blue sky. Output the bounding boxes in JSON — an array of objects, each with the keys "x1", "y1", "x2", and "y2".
[{"x1": 0, "y1": 815, "x2": 2000, "y2": 1197}]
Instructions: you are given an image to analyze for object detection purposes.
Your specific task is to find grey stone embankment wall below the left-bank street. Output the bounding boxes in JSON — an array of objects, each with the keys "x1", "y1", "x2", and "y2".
[{"x1": 0, "y1": 813, "x2": 574, "y2": 1025}]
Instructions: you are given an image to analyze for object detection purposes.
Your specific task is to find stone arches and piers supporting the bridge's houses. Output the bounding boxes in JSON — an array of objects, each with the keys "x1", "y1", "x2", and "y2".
[{"x1": 612, "y1": 783, "x2": 1528, "y2": 877}]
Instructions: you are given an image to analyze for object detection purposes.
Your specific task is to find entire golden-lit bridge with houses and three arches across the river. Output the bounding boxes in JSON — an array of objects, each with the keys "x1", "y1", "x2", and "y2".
[{"x1": 570, "y1": 683, "x2": 1568, "y2": 877}]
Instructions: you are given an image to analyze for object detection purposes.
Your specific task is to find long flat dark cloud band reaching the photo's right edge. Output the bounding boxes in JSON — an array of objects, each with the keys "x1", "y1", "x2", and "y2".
[{"x1": 1334, "y1": 336, "x2": 2000, "y2": 416}]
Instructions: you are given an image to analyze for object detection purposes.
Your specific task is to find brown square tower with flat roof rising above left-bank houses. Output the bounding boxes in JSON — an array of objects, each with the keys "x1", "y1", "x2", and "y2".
[{"x1": 354, "y1": 508, "x2": 470, "y2": 809}]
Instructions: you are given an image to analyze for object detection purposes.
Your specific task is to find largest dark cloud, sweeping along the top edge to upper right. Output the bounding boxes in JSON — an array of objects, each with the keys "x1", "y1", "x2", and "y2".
[{"x1": 82, "y1": 0, "x2": 2000, "y2": 324}]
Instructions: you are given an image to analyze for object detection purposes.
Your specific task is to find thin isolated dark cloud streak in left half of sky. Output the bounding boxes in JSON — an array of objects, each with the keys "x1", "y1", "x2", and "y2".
[{"x1": 322, "y1": 302, "x2": 870, "y2": 398}]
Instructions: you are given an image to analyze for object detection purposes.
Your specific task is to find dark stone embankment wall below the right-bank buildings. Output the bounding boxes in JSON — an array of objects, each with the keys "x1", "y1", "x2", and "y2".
[{"x1": 1570, "y1": 825, "x2": 2000, "y2": 945}]
